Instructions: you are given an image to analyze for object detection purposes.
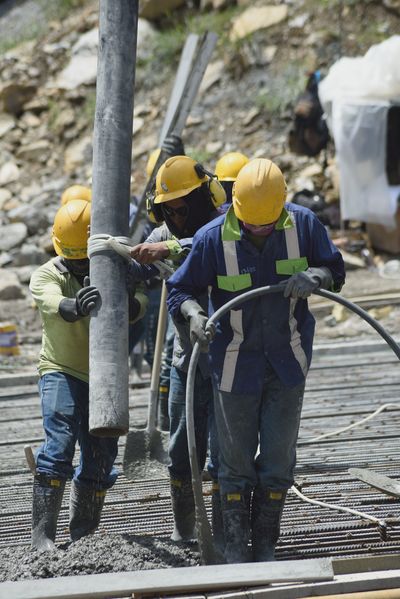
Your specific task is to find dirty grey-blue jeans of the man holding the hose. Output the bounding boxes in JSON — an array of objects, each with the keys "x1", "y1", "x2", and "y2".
[{"x1": 215, "y1": 368, "x2": 305, "y2": 493}]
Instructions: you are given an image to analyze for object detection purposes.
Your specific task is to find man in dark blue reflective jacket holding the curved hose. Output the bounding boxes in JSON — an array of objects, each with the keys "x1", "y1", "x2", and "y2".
[{"x1": 167, "y1": 158, "x2": 345, "y2": 563}]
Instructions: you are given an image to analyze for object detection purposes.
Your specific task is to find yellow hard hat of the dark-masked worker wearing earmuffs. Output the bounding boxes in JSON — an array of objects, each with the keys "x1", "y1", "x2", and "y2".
[{"x1": 154, "y1": 156, "x2": 209, "y2": 204}]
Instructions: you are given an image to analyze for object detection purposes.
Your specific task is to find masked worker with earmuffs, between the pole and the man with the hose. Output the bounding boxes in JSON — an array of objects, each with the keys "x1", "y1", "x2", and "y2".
[{"x1": 131, "y1": 156, "x2": 226, "y2": 541}]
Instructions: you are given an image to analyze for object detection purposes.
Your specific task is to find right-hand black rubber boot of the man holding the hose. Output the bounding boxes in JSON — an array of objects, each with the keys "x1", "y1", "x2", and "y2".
[{"x1": 251, "y1": 487, "x2": 287, "y2": 562}]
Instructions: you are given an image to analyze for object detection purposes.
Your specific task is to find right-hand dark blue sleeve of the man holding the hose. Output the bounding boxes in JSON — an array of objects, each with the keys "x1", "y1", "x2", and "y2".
[{"x1": 306, "y1": 211, "x2": 346, "y2": 292}]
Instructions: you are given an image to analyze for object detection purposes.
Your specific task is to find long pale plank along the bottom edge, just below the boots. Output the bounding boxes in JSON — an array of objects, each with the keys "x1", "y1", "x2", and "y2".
[{"x1": 0, "y1": 558, "x2": 333, "y2": 599}]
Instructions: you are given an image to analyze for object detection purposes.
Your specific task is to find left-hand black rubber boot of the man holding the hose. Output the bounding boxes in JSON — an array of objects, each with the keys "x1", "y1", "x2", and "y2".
[{"x1": 221, "y1": 493, "x2": 251, "y2": 564}]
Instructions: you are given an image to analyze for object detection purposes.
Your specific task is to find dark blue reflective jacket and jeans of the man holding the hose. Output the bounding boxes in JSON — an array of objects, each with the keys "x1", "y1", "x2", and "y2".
[{"x1": 167, "y1": 204, "x2": 345, "y2": 493}]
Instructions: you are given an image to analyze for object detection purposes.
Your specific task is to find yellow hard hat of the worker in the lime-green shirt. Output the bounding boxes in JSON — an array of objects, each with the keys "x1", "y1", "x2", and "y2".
[{"x1": 52, "y1": 200, "x2": 91, "y2": 260}]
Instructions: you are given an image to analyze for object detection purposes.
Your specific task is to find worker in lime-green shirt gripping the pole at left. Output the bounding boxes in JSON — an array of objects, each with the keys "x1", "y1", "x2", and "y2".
[{"x1": 30, "y1": 200, "x2": 146, "y2": 550}]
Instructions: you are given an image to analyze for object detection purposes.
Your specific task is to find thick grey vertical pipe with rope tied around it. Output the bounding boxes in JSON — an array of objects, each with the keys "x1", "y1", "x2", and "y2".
[{"x1": 89, "y1": 0, "x2": 138, "y2": 437}]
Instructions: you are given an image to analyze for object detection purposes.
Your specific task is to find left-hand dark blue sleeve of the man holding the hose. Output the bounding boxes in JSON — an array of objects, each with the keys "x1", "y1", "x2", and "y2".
[{"x1": 167, "y1": 232, "x2": 215, "y2": 319}]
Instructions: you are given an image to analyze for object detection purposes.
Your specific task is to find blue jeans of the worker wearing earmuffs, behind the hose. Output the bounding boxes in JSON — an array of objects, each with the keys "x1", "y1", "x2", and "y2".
[{"x1": 168, "y1": 366, "x2": 213, "y2": 480}]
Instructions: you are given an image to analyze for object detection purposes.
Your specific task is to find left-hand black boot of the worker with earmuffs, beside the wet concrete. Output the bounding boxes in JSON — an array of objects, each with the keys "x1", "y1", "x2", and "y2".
[{"x1": 171, "y1": 478, "x2": 196, "y2": 541}]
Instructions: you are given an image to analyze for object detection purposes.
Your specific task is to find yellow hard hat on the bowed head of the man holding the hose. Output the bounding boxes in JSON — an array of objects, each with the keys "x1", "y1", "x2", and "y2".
[{"x1": 232, "y1": 158, "x2": 286, "y2": 225}]
